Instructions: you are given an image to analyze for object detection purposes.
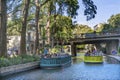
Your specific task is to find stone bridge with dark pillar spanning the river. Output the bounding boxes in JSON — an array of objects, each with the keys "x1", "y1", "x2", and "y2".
[{"x1": 55, "y1": 33, "x2": 120, "y2": 56}]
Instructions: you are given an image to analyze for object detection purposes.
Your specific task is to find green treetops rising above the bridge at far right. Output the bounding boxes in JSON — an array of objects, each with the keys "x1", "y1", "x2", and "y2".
[{"x1": 96, "y1": 14, "x2": 120, "y2": 32}]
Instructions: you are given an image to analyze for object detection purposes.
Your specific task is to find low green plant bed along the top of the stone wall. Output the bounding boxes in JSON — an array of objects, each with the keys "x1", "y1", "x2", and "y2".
[{"x1": 0, "y1": 55, "x2": 39, "y2": 67}]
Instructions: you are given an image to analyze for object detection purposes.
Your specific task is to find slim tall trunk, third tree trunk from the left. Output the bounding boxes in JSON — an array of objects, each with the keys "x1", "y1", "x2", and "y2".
[{"x1": 34, "y1": 0, "x2": 40, "y2": 54}]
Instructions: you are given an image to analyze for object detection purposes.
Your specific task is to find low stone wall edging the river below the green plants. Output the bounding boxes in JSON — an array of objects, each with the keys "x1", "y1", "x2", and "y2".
[{"x1": 0, "y1": 61, "x2": 39, "y2": 76}]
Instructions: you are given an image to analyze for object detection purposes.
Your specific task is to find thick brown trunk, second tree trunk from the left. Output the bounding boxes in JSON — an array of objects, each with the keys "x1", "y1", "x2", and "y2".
[{"x1": 20, "y1": 0, "x2": 30, "y2": 54}]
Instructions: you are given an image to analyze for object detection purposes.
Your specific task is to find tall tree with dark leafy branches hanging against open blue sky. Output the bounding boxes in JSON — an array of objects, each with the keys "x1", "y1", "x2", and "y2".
[{"x1": 42, "y1": 0, "x2": 97, "y2": 48}]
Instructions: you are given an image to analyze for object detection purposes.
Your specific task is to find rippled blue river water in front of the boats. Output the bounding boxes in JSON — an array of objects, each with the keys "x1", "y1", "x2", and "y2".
[{"x1": 0, "y1": 55, "x2": 120, "y2": 80}]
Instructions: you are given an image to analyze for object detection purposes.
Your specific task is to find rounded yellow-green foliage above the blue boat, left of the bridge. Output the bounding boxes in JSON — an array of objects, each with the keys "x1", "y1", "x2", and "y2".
[{"x1": 50, "y1": 15, "x2": 72, "y2": 41}]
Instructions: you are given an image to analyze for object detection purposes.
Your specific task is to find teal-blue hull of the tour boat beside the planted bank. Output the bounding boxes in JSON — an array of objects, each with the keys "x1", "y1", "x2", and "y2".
[{"x1": 40, "y1": 55, "x2": 72, "y2": 68}]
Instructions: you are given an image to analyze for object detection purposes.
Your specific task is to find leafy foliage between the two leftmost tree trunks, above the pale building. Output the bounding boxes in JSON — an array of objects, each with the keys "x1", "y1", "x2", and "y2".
[{"x1": 7, "y1": 0, "x2": 24, "y2": 36}]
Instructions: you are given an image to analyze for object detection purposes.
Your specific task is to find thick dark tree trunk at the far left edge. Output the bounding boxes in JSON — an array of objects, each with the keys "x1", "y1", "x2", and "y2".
[{"x1": 0, "y1": 0, "x2": 7, "y2": 57}]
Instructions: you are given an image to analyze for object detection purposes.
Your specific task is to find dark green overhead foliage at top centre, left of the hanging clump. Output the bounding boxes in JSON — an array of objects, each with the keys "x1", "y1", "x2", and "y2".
[{"x1": 49, "y1": 0, "x2": 79, "y2": 17}]
